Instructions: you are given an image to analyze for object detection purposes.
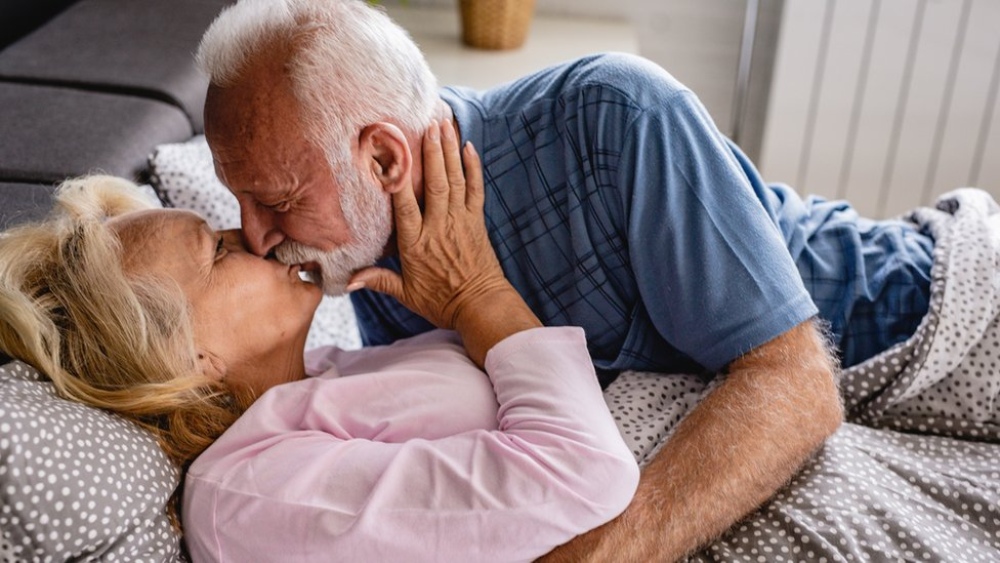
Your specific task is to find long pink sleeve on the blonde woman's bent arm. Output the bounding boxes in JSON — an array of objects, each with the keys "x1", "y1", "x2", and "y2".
[{"x1": 185, "y1": 328, "x2": 639, "y2": 561}]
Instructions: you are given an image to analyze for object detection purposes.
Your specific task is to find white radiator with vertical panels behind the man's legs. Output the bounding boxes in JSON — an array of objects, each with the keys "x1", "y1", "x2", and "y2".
[{"x1": 759, "y1": 0, "x2": 1000, "y2": 217}]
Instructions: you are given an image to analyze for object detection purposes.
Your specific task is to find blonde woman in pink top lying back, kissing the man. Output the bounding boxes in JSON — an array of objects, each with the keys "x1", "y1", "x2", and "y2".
[{"x1": 0, "y1": 124, "x2": 638, "y2": 561}]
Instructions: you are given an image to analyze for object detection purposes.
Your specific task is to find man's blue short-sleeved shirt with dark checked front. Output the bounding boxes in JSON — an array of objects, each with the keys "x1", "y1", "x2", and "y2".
[{"x1": 352, "y1": 54, "x2": 928, "y2": 371}]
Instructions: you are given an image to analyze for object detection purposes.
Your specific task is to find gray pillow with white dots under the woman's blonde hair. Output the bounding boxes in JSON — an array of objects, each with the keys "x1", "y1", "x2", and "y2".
[{"x1": 0, "y1": 362, "x2": 181, "y2": 561}]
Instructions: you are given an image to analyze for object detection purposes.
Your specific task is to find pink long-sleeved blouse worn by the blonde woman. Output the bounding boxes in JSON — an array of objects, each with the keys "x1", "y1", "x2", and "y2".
[{"x1": 183, "y1": 328, "x2": 639, "y2": 562}]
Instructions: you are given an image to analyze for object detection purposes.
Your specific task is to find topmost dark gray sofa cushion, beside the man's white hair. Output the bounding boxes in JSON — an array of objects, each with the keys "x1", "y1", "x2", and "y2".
[{"x1": 0, "y1": 0, "x2": 229, "y2": 132}]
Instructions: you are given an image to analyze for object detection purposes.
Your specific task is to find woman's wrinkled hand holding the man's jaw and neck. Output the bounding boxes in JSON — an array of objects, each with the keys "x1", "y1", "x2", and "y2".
[{"x1": 351, "y1": 120, "x2": 513, "y2": 338}]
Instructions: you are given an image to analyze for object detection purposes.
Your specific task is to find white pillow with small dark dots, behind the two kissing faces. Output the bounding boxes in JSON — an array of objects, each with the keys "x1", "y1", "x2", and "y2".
[{"x1": 149, "y1": 135, "x2": 361, "y2": 349}]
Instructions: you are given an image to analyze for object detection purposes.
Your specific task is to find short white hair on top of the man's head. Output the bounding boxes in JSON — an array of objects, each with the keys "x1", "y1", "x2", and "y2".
[{"x1": 196, "y1": 0, "x2": 439, "y2": 162}]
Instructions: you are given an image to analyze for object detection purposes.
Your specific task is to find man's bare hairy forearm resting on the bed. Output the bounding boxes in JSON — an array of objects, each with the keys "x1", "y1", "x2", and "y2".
[{"x1": 541, "y1": 321, "x2": 843, "y2": 563}]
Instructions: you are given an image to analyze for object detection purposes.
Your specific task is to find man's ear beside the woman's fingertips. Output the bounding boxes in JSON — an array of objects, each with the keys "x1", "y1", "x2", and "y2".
[{"x1": 358, "y1": 121, "x2": 413, "y2": 193}]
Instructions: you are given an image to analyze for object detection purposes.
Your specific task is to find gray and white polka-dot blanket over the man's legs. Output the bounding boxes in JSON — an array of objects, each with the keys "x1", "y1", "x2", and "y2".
[{"x1": 605, "y1": 190, "x2": 1000, "y2": 563}]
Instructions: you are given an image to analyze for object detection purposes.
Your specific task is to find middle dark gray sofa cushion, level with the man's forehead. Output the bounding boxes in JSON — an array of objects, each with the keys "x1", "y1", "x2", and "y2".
[{"x1": 0, "y1": 83, "x2": 192, "y2": 183}]
